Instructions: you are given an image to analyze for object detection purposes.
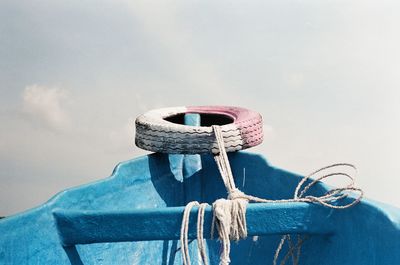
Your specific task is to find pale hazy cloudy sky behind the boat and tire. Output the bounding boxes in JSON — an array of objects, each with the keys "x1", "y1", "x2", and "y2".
[{"x1": 0, "y1": 0, "x2": 400, "y2": 216}]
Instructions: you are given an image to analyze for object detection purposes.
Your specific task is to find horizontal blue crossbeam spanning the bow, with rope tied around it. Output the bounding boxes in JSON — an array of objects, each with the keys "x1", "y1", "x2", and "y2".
[{"x1": 53, "y1": 203, "x2": 334, "y2": 246}]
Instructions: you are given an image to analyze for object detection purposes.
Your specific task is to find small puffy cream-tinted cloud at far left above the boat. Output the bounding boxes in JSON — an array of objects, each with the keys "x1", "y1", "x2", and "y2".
[{"x1": 22, "y1": 84, "x2": 70, "y2": 130}]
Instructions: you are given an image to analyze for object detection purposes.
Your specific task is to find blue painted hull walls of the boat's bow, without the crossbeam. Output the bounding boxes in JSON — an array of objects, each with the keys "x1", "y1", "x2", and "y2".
[{"x1": 0, "y1": 112, "x2": 400, "y2": 265}]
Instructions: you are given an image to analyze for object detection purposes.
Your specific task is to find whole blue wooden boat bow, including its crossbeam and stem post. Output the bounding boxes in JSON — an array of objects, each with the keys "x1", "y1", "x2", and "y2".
[{"x1": 0, "y1": 106, "x2": 400, "y2": 265}]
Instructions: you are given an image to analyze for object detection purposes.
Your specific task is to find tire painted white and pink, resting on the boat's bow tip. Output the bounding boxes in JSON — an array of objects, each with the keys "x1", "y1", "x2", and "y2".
[{"x1": 135, "y1": 106, "x2": 263, "y2": 154}]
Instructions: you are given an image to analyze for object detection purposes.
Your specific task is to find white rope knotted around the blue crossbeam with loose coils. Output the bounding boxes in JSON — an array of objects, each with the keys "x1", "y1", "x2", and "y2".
[{"x1": 180, "y1": 125, "x2": 363, "y2": 265}]
